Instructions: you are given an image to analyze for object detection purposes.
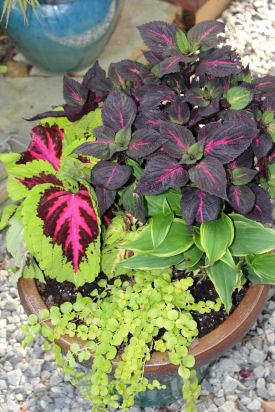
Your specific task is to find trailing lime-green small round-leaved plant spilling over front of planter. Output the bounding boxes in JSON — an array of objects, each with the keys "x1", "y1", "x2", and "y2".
[{"x1": 22, "y1": 268, "x2": 220, "y2": 412}]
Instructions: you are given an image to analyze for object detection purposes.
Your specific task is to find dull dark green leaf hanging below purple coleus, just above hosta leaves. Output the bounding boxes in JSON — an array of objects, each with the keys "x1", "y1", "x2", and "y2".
[{"x1": 121, "y1": 182, "x2": 146, "y2": 223}]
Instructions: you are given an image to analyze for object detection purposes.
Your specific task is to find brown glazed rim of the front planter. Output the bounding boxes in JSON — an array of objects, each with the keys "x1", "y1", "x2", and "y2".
[{"x1": 18, "y1": 278, "x2": 269, "y2": 373}]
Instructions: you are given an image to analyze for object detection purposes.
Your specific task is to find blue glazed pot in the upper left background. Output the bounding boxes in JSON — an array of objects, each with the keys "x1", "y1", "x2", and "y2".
[{"x1": 0, "y1": 0, "x2": 119, "y2": 74}]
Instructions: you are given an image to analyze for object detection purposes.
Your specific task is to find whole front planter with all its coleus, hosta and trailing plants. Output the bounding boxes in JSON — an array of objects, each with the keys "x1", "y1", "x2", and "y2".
[{"x1": 0, "y1": 21, "x2": 275, "y2": 411}]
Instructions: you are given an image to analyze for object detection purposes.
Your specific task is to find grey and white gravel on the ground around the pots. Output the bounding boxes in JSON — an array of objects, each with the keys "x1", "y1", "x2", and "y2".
[{"x1": 0, "y1": 0, "x2": 275, "y2": 412}]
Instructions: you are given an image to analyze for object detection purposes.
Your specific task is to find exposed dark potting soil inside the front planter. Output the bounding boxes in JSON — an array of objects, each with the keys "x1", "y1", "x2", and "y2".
[{"x1": 36, "y1": 270, "x2": 248, "y2": 338}]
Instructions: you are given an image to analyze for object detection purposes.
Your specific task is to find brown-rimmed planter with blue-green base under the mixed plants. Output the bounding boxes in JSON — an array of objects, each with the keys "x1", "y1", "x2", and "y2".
[{"x1": 18, "y1": 278, "x2": 269, "y2": 407}]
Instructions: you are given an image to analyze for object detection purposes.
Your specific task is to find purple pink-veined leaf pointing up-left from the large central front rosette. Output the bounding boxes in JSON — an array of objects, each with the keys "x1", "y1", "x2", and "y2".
[{"x1": 160, "y1": 122, "x2": 195, "y2": 159}]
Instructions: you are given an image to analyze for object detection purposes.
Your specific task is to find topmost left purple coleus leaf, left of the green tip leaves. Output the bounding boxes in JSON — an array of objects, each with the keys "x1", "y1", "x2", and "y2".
[{"x1": 137, "y1": 21, "x2": 177, "y2": 54}]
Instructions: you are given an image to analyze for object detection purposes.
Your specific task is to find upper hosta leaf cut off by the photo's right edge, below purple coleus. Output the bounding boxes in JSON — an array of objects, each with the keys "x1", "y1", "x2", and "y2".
[{"x1": 229, "y1": 213, "x2": 275, "y2": 256}]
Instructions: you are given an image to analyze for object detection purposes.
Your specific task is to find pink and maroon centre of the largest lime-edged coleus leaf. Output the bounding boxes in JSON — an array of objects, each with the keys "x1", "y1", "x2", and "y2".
[{"x1": 37, "y1": 187, "x2": 99, "y2": 276}]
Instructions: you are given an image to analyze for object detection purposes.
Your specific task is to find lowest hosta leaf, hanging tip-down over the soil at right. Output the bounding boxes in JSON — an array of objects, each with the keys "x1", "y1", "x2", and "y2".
[{"x1": 207, "y1": 261, "x2": 239, "y2": 313}]
